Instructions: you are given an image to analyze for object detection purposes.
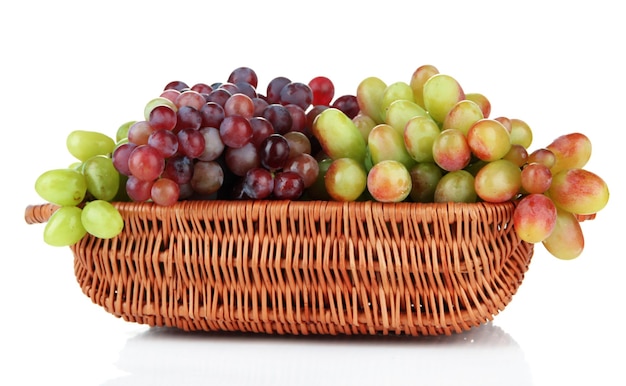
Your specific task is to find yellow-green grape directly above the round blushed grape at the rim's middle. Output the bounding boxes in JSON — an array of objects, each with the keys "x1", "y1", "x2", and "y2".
[{"x1": 367, "y1": 123, "x2": 415, "y2": 168}]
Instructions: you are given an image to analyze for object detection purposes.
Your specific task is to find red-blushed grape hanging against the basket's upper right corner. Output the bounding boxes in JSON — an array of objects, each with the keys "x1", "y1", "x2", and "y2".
[{"x1": 513, "y1": 193, "x2": 557, "y2": 243}]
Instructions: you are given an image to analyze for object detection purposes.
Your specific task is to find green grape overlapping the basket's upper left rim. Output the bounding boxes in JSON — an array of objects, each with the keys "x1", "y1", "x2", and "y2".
[{"x1": 80, "y1": 200, "x2": 124, "y2": 239}]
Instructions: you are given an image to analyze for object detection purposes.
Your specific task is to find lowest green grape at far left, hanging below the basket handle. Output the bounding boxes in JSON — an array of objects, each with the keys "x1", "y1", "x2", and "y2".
[{"x1": 43, "y1": 206, "x2": 87, "y2": 247}]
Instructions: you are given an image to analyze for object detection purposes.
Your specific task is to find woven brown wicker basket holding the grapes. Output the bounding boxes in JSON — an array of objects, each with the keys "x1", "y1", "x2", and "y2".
[{"x1": 25, "y1": 200, "x2": 533, "y2": 336}]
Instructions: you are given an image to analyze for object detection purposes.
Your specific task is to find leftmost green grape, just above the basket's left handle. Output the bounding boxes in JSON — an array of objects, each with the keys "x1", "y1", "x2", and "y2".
[{"x1": 35, "y1": 169, "x2": 87, "y2": 206}]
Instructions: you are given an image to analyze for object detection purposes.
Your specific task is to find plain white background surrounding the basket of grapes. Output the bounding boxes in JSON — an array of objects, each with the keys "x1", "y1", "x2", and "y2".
[{"x1": 0, "y1": 0, "x2": 626, "y2": 385}]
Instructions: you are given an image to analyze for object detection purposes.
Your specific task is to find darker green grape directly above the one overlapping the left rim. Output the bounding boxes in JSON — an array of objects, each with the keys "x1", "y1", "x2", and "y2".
[{"x1": 82, "y1": 155, "x2": 120, "y2": 201}]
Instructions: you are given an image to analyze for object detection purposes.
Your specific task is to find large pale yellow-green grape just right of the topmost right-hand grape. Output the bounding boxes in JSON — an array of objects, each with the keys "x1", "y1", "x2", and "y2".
[{"x1": 423, "y1": 74, "x2": 465, "y2": 123}]
